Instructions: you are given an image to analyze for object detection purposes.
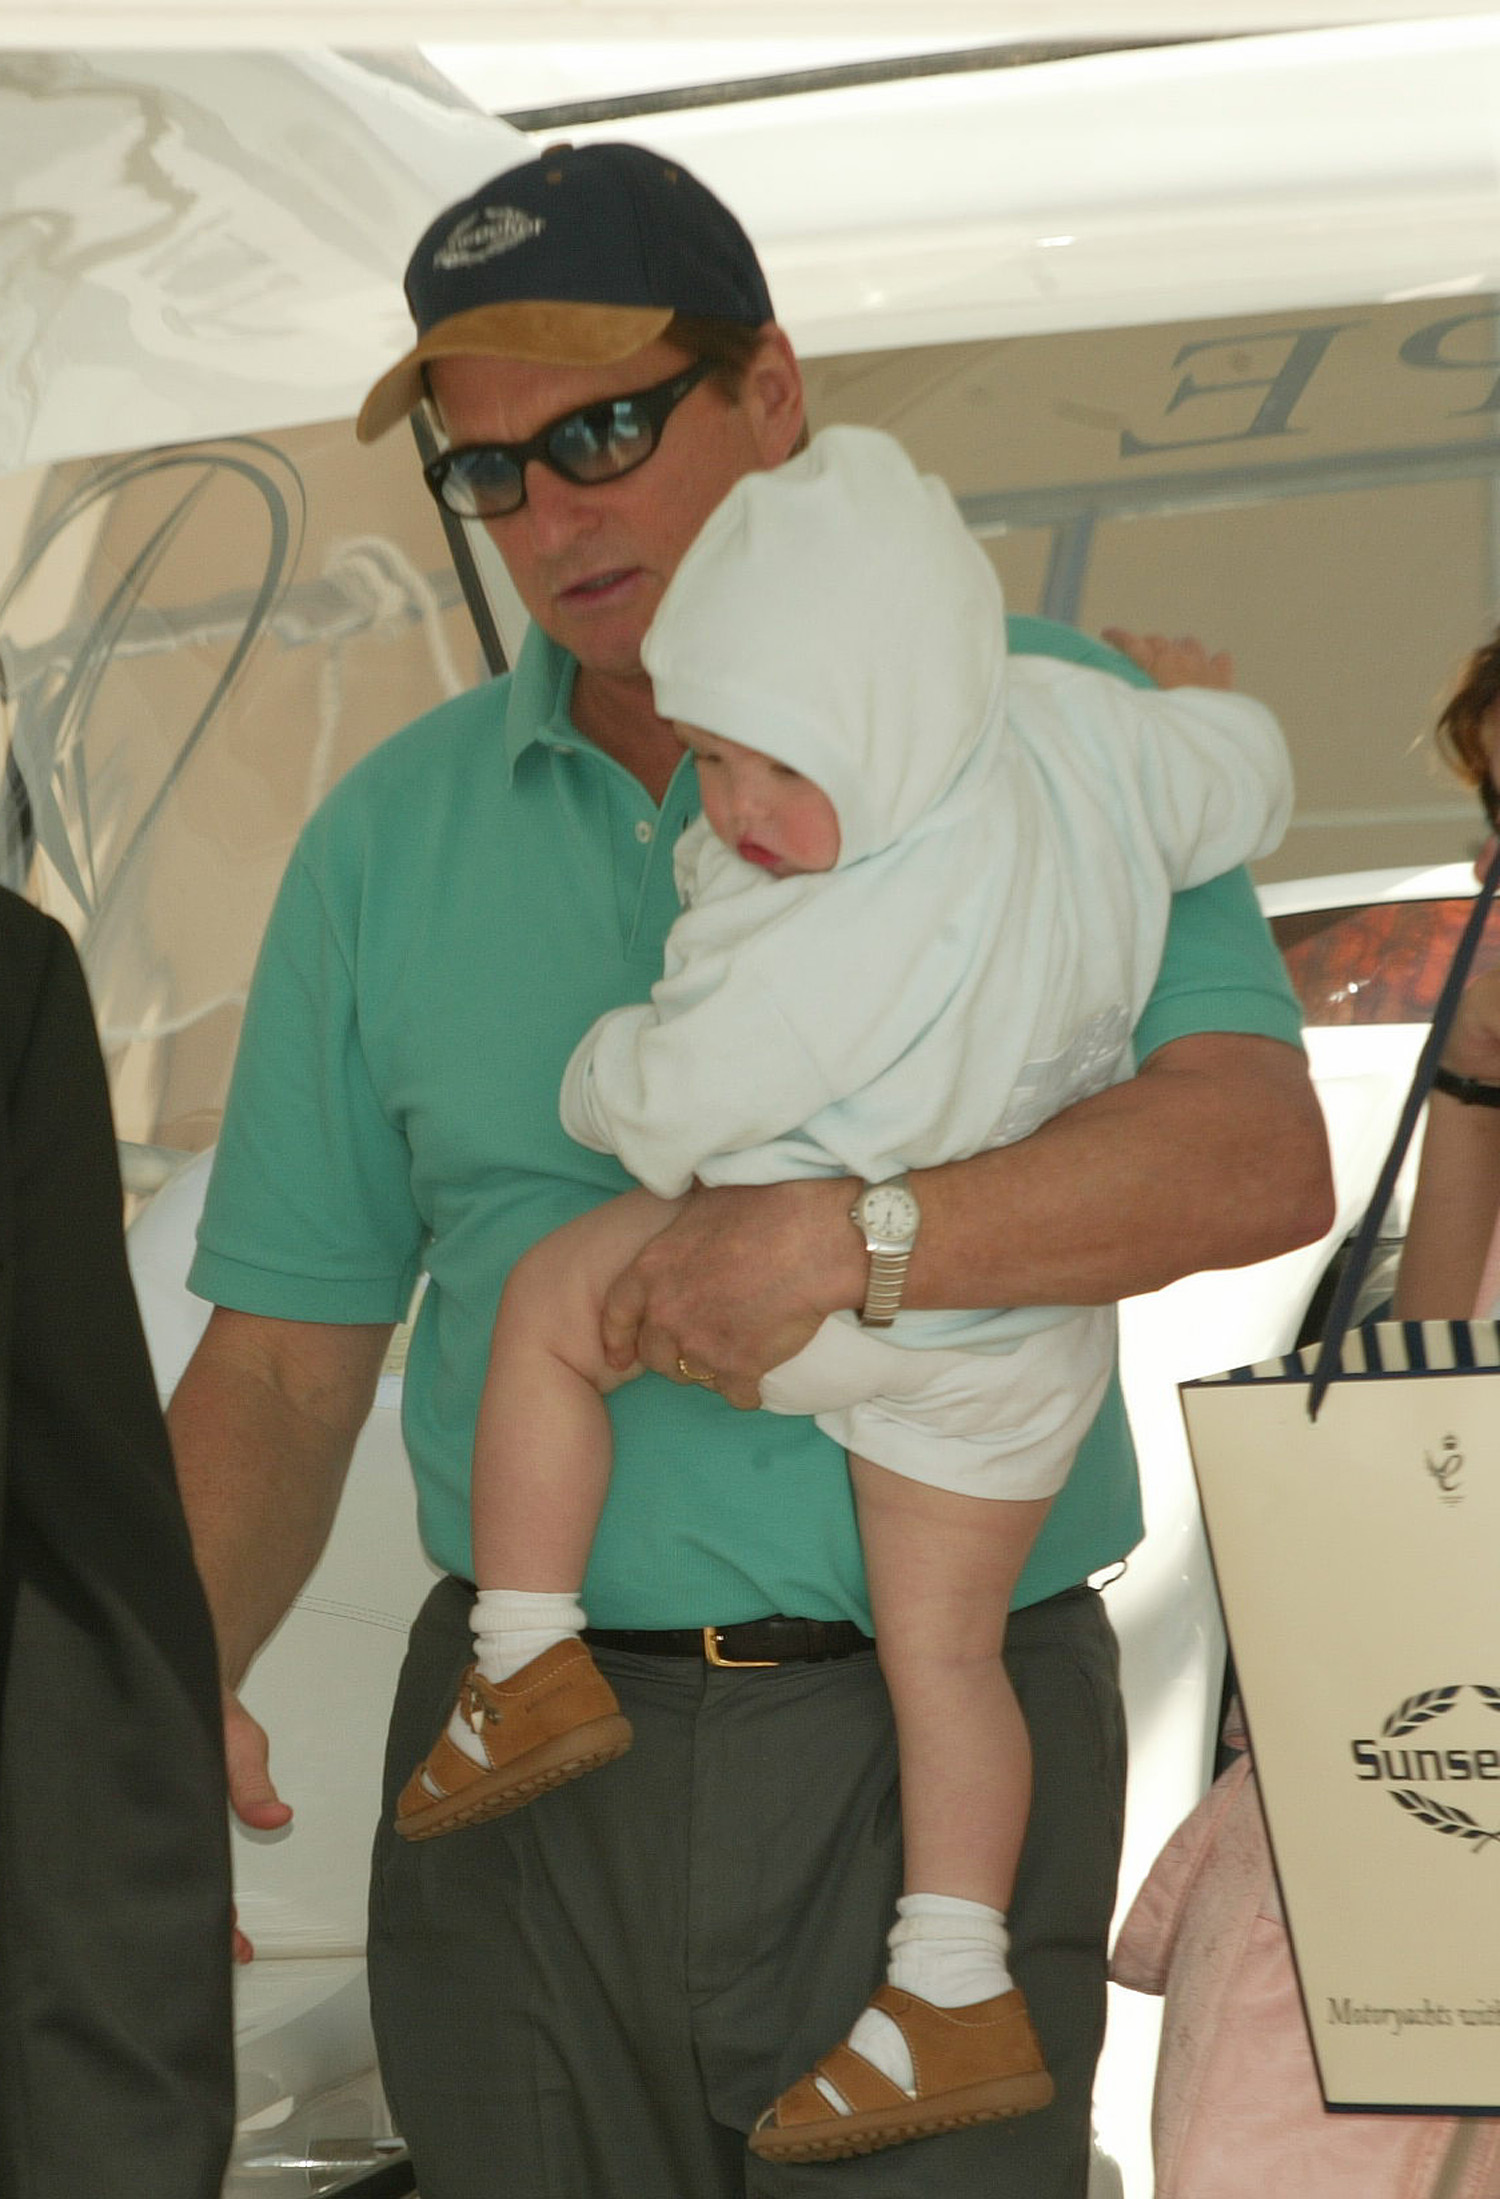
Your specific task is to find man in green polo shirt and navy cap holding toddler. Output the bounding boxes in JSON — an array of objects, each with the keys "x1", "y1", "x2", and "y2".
[{"x1": 174, "y1": 147, "x2": 1328, "y2": 2199}]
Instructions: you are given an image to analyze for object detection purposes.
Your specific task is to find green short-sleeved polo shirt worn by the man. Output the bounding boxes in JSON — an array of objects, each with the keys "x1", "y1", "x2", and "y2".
[{"x1": 189, "y1": 620, "x2": 1298, "y2": 1627}]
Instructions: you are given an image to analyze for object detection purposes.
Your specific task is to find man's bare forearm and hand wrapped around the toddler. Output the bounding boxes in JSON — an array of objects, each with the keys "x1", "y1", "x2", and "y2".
[{"x1": 605, "y1": 1034, "x2": 1333, "y2": 1405}]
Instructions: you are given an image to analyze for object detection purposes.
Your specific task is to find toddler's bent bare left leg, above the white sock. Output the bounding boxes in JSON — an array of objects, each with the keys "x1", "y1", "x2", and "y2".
[{"x1": 473, "y1": 1192, "x2": 680, "y2": 1592}]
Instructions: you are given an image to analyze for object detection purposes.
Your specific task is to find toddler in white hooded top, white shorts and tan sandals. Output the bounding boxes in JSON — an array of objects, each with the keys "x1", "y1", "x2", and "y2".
[{"x1": 396, "y1": 429, "x2": 1289, "y2": 2159}]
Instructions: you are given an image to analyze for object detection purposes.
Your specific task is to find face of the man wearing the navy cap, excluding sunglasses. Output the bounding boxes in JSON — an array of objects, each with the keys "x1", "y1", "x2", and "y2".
[{"x1": 431, "y1": 332, "x2": 801, "y2": 675}]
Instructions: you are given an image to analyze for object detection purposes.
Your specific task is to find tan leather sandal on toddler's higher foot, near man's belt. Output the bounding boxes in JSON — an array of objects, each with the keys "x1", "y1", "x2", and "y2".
[{"x1": 396, "y1": 1640, "x2": 631, "y2": 1841}]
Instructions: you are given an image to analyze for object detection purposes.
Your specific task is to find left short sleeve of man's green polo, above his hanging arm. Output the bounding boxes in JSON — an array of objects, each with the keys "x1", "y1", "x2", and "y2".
[{"x1": 189, "y1": 836, "x2": 422, "y2": 1322}]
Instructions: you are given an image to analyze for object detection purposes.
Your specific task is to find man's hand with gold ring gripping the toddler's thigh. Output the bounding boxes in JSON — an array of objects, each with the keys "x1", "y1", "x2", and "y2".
[{"x1": 600, "y1": 1176, "x2": 864, "y2": 1412}]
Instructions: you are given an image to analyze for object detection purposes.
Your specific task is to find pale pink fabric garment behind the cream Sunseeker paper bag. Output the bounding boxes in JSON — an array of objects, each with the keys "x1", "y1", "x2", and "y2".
[{"x1": 1111, "y1": 1755, "x2": 1500, "y2": 2199}]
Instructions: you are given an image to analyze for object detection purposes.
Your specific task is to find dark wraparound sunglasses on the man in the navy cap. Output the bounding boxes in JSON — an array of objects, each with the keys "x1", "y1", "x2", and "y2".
[{"x1": 422, "y1": 358, "x2": 710, "y2": 519}]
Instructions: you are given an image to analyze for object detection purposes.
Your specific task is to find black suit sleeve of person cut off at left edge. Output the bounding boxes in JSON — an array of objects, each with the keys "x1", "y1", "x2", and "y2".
[{"x1": 0, "y1": 893, "x2": 233, "y2": 2199}]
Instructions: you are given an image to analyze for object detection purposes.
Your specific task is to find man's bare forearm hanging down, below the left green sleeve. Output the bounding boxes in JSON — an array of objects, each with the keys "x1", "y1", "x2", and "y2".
[{"x1": 167, "y1": 1311, "x2": 389, "y2": 1689}]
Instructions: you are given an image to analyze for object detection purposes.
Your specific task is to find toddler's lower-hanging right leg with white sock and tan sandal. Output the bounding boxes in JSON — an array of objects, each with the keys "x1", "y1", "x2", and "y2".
[{"x1": 750, "y1": 1454, "x2": 1051, "y2": 2162}]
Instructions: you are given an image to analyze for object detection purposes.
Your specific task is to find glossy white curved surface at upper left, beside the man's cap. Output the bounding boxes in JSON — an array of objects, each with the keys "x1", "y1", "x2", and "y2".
[{"x1": 0, "y1": 51, "x2": 532, "y2": 471}]
